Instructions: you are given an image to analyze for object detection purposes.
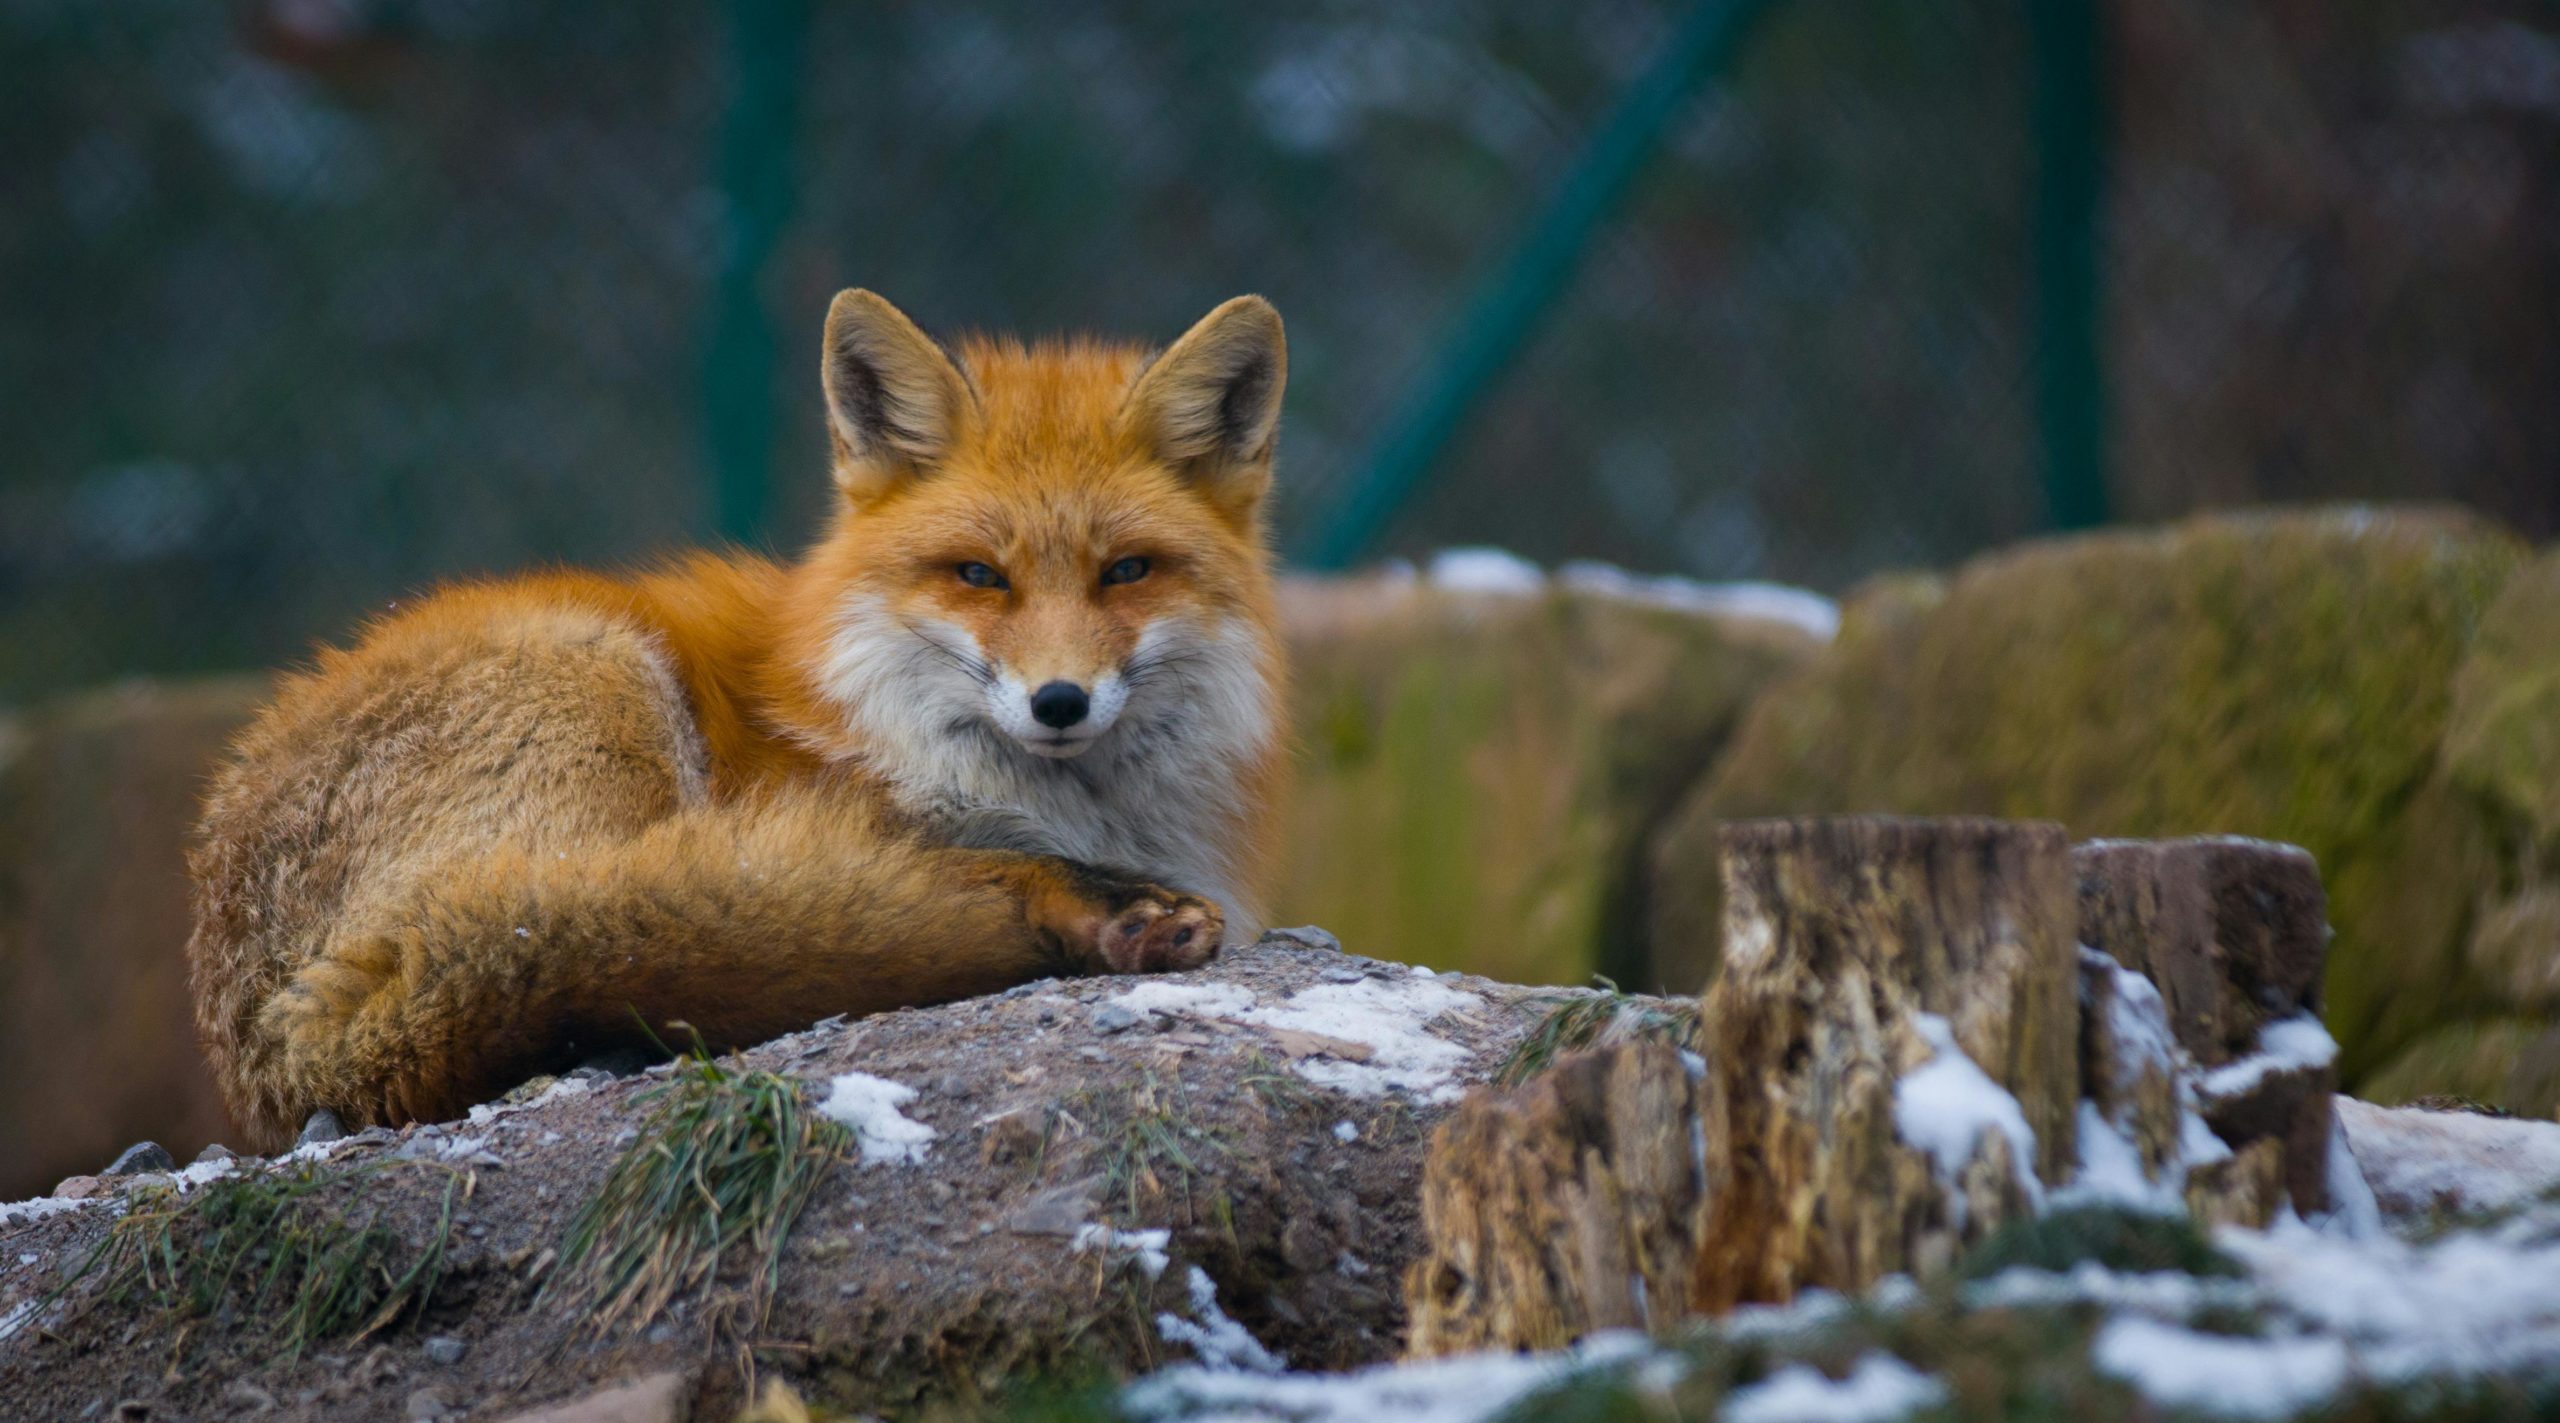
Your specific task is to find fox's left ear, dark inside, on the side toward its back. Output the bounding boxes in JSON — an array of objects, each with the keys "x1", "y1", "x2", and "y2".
[{"x1": 819, "y1": 287, "x2": 975, "y2": 504}]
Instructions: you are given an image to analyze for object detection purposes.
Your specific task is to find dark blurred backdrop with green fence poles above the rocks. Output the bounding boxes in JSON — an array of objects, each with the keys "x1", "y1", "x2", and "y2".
[{"x1": 0, "y1": 0, "x2": 2560, "y2": 701}]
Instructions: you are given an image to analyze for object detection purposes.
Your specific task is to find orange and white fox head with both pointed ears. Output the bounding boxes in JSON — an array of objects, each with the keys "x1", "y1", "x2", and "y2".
[{"x1": 757, "y1": 292, "x2": 1288, "y2": 799}]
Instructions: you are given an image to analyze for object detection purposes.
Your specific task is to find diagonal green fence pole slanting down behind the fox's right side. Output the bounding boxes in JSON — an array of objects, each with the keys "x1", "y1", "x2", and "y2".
[{"x1": 1298, "y1": 0, "x2": 1769, "y2": 568}]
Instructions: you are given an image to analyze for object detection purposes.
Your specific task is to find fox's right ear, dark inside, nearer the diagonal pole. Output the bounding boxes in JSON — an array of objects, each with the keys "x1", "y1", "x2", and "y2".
[{"x1": 1126, "y1": 297, "x2": 1288, "y2": 514}]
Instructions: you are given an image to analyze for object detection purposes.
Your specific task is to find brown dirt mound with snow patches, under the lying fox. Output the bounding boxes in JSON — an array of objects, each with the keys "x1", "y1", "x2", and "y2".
[{"x1": 0, "y1": 932, "x2": 1559, "y2": 1423}]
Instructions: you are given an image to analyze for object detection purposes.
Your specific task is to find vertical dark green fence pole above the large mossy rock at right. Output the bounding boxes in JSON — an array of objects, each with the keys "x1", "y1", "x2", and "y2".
[{"x1": 2025, "y1": 0, "x2": 2107, "y2": 530}]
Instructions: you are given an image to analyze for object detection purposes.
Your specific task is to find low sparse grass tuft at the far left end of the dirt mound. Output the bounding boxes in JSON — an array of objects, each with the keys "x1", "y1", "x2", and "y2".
[{"x1": 64, "y1": 1162, "x2": 471, "y2": 1359}]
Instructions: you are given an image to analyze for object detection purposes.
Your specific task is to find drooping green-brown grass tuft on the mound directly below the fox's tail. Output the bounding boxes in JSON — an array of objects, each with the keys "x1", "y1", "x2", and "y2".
[{"x1": 543, "y1": 1052, "x2": 852, "y2": 1336}]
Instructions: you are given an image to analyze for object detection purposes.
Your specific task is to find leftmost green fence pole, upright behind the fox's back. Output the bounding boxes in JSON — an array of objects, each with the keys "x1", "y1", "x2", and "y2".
[{"x1": 701, "y1": 0, "x2": 809, "y2": 543}]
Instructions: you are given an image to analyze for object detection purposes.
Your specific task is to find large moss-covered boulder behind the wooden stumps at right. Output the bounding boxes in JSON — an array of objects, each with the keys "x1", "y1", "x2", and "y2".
[{"x1": 1651, "y1": 509, "x2": 2527, "y2": 1083}]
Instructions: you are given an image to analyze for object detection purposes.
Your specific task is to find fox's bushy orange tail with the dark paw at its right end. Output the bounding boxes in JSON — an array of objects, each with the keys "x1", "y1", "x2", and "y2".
[{"x1": 256, "y1": 796, "x2": 1224, "y2": 1136}]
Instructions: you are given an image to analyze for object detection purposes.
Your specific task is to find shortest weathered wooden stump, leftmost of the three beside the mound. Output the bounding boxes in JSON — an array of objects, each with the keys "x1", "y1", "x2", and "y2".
[{"x1": 1402, "y1": 1042, "x2": 1705, "y2": 1356}]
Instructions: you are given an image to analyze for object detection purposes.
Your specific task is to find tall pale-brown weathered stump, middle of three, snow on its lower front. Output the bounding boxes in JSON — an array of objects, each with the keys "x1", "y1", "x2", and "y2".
[{"x1": 1695, "y1": 816, "x2": 2079, "y2": 1313}]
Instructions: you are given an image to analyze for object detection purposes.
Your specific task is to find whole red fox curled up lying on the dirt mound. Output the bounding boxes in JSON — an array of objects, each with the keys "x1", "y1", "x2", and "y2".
[{"x1": 187, "y1": 292, "x2": 1288, "y2": 1149}]
